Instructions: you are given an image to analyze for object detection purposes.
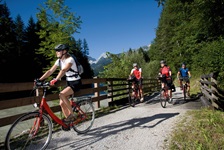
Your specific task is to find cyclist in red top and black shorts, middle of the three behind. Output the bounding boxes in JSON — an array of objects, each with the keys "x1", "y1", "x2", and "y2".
[{"x1": 159, "y1": 60, "x2": 172, "y2": 101}]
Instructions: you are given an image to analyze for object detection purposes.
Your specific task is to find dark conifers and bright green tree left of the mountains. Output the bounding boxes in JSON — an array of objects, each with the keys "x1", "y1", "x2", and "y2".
[{"x1": 0, "y1": 0, "x2": 93, "y2": 83}]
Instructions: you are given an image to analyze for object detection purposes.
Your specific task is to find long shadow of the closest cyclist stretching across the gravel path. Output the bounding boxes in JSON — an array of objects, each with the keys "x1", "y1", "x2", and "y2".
[{"x1": 49, "y1": 113, "x2": 179, "y2": 150}]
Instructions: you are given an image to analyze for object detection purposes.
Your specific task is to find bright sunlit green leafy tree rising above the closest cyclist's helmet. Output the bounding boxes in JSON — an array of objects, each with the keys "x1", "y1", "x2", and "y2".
[{"x1": 37, "y1": 0, "x2": 81, "y2": 66}]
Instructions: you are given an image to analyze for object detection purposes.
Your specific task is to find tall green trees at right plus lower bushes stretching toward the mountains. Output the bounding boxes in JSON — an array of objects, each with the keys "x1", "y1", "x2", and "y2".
[{"x1": 101, "y1": 0, "x2": 224, "y2": 86}]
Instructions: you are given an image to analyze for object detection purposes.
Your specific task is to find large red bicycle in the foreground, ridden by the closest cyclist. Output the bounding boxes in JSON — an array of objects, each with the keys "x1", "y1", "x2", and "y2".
[{"x1": 5, "y1": 82, "x2": 95, "y2": 150}]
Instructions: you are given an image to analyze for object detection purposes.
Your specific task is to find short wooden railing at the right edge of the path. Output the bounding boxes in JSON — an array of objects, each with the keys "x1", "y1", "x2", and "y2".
[{"x1": 200, "y1": 73, "x2": 224, "y2": 110}]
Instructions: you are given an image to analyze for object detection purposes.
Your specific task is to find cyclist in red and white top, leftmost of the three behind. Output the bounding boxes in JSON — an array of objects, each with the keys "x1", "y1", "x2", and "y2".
[{"x1": 129, "y1": 63, "x2": 144, "y2": 102}]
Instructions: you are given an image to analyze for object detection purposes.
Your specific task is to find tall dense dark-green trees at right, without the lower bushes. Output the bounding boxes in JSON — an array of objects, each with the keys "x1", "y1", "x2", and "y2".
[{"x1": 148, "y1": 0, "x2": 224, "y2": 82}]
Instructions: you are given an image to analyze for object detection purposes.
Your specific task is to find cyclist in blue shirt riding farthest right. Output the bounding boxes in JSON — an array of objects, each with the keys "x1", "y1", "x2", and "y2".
[{"x1": 177, "y1": 63, "x2": 191, "y2": 96}]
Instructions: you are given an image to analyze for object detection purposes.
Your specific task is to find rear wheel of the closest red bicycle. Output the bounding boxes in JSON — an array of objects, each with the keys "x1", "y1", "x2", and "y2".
[{"x1": 72, "y1": 100, "x2": 95, "y2": 134}]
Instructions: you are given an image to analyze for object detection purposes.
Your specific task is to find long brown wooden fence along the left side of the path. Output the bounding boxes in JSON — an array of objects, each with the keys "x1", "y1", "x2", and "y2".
[{"x1": 0, "y1": 78, "x2": 159, "y2": 127}]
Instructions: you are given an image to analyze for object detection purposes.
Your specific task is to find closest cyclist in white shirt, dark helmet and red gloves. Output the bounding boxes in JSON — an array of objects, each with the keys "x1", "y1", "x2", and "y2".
[{"x1": 38, "y1": 44, "x2": 82, "y2": 123}]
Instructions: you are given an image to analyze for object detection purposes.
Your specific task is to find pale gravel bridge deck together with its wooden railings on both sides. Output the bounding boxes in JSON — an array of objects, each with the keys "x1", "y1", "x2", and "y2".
[{"x1": 0, "y1": 74, "x2": 224, "y2": 150}]
